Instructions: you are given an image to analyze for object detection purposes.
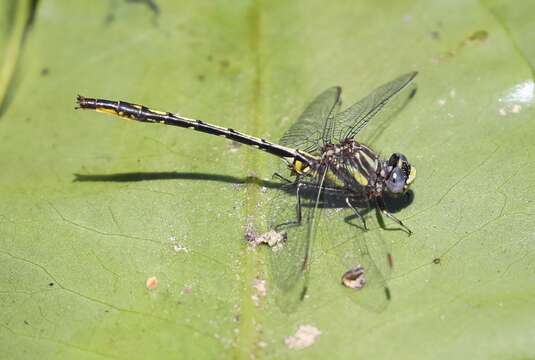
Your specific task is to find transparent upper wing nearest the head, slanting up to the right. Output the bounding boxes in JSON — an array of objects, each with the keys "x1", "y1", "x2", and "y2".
[{"x1": 336, "y1": 72, "x2": 418, "y2": 141}]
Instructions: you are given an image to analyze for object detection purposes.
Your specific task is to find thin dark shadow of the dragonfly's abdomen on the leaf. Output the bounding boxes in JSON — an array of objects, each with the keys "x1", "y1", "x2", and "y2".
[{"x1": 73, "y1": 171, "x2": 280, "y2": 188}]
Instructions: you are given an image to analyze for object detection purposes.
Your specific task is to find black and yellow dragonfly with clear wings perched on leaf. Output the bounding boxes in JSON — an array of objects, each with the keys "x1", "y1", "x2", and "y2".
[{"x1": 76, "y1": 72, "x2": 417, "y2": 307}]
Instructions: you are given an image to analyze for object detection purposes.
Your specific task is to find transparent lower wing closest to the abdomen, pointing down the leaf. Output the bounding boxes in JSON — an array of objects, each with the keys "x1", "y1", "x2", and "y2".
[{"x1": 268, "y1": 167, "x2": 323, "y2": 312}]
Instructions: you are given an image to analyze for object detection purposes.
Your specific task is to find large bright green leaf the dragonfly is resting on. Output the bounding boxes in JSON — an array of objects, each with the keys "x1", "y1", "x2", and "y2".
[{"x1": 0, "y1": 0, "x2": 535, "y2": 359}]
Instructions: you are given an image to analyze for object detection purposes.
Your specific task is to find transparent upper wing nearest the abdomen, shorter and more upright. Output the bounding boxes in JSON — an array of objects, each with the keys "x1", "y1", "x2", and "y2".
[{"x1": 279, "y1": 86, "x2": 342, "y2": 153}]
